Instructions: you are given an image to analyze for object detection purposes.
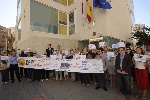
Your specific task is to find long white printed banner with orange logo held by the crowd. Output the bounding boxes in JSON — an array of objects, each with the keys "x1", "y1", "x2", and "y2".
[{"x1": 18, "y1": 57, "x2": 104, "y2": 73}]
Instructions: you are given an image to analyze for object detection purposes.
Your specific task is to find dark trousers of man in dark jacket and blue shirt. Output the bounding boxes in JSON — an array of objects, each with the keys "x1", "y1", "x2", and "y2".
[{"x1": 118, "y1": 74, "x2": 131, "y2": 95}]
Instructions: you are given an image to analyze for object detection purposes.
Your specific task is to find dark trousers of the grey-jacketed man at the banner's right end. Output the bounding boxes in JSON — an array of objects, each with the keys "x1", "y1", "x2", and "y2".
[{"x1": 94, "y1": 72, "x2": 106, "y2": 87}]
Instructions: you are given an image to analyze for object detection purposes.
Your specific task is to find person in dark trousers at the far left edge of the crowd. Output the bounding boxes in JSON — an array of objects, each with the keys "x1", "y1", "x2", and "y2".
[{"x1": 1, "y1": 52, "x2": 9, "y2": 84}]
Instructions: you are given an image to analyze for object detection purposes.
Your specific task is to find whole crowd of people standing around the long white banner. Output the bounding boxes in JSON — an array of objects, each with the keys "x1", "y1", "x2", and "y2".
[{"x1": 1, "y1": 44, "x2": 150, "y2": 100}]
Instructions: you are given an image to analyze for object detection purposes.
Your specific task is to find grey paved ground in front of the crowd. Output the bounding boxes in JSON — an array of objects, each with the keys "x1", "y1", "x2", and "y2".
[{"x1": 0, "y1": 79, "x2": 150, "y2": 100}]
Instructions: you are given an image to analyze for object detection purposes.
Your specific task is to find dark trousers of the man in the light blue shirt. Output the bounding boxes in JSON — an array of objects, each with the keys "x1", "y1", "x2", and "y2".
[{"x1": 9, "y1": 64, "x2": 20, "y2": 81}]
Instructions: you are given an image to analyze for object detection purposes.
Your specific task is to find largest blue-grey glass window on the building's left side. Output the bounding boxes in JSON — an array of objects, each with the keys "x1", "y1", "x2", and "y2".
[{"x1": 30, "y1": 0, "x2": 58, "y2": 34}]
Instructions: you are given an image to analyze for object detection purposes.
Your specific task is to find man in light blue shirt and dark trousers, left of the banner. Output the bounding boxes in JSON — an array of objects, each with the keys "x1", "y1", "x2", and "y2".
[{"x1": 9, "y1": 51, "x2": 21, "y2": 83}]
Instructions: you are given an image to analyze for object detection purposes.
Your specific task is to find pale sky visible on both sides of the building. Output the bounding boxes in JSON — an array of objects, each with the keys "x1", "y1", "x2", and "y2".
[{"x1": 0, "y1": 0, "x2": 150, "y2": 28}]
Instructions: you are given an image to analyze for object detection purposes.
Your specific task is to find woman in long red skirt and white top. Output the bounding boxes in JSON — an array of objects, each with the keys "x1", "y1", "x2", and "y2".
[{"x1": 134, "y1": 47, "x2": 149, "y2": 100}]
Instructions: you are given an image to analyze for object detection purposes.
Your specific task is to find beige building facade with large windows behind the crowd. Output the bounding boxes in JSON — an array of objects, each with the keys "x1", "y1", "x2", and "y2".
[{"x1": 14, "y1": 0, "x2": 134, "y2": 54}]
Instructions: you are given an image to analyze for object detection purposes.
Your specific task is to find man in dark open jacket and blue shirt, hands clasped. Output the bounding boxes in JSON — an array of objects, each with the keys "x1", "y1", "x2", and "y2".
[{"x1": 115, "y1": 47, "x2": 132, "y2": 100}]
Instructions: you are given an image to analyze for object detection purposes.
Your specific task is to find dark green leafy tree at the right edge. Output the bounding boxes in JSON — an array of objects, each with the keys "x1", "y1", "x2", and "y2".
[{"x1": 130, "y1": 27, "x2": 150, "y2": 46}]
